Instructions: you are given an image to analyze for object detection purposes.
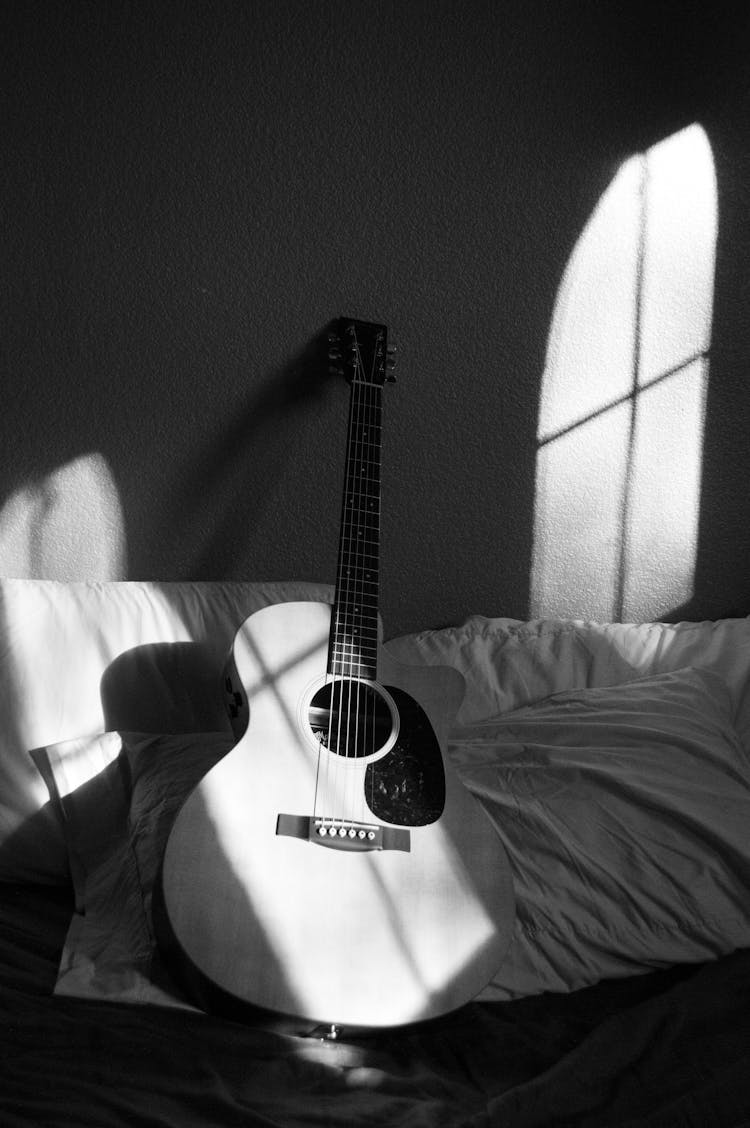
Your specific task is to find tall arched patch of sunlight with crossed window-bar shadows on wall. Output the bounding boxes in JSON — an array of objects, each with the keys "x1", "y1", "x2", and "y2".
[{"x1": 530, "y1": 125, "x2": 717, "y2": 620}]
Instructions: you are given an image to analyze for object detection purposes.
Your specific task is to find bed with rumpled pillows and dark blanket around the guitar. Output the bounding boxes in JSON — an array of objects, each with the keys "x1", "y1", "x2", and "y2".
[{"x1": 0, "y1": 580, "x2": 750, "y2": 1128}]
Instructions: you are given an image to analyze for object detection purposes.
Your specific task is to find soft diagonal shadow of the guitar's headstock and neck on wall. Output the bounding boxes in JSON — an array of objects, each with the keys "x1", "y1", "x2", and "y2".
[{"x1": 176, "y1": 320, "x2": 341, "y2": 580}]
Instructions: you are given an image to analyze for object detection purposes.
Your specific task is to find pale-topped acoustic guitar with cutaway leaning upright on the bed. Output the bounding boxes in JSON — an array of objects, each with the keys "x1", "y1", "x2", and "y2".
[{"x1": 158, "y1": 320, "x2": 514, "y2": 1028}]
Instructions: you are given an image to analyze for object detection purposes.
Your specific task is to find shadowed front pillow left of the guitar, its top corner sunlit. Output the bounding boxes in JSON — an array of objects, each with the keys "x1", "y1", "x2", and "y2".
[{"x1": 35, "y1": 732, "x2": 235, "y2": 1005}]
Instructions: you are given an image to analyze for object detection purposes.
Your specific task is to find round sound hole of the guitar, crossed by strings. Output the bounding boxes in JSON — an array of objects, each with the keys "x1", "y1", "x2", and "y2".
[{"x1": 308, "y1": 678, "x2": 394, "y2": 756}]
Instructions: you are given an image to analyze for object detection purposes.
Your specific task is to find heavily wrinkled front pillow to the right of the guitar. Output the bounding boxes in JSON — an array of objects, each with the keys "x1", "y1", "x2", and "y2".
[{"x1": 450, "y1": 669, "x2": 750, "y2": 999}]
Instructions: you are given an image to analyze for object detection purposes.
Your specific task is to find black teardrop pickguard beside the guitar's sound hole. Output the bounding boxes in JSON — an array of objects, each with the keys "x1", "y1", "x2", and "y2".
[{"x1": 364, "y1": 686, "x2": 445, "y2": 827}]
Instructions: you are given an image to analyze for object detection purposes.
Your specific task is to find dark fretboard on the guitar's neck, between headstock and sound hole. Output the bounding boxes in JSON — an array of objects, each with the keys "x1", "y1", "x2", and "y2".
[{"x1": 328, "y1": 379, "x2": 382, "y2": 680}]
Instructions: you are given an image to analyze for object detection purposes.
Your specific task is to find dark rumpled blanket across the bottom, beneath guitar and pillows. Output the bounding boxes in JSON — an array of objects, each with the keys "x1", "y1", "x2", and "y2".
[{"x1": 0, "y1": 887, "x2": 750, "y2": 1128}]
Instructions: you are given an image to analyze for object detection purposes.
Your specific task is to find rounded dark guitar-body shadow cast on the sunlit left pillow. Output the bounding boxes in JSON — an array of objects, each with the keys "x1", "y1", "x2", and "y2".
[{"x1": 100, "y1": 642, "x2": 231, "y2": 733}]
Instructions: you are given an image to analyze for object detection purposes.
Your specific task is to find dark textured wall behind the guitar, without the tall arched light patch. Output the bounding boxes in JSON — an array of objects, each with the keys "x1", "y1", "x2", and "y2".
[{"x1": 0, "y1": 0, "x2": 750, "y2": 635}]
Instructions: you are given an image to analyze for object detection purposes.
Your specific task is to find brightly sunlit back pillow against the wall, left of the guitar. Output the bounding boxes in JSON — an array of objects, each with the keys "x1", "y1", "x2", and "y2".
[{"x1": 0, "y1": 580, "x2": 333, "y2": 882}]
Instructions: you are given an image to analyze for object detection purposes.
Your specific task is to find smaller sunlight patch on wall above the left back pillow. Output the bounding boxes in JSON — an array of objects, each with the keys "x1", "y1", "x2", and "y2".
[{"x1": 0, "y1": 453, "x2": 127, "y2": 581}]
